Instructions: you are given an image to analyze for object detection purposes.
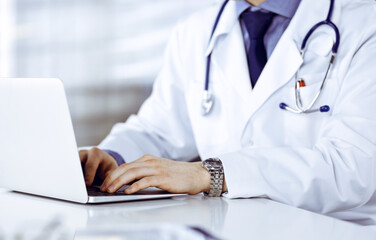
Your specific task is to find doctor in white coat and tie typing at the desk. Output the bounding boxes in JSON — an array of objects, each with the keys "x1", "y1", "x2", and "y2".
[{"x1": 80, "y1": 0, "x2": 376, "y2": 224}]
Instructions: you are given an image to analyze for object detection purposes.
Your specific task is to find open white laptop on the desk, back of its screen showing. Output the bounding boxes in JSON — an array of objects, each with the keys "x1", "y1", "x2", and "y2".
[{"x1": 0, "y1": 78, "x2": 185, "y2": 203}]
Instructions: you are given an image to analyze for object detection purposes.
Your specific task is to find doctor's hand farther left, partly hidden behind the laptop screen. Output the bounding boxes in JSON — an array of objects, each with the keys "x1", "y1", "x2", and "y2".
[{"x1": 79, "y1": 147, "x2": 118, "y2": 186}]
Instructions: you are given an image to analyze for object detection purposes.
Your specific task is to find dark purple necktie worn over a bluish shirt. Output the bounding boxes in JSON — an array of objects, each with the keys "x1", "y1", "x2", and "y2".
[{"x1": 239, "y1": 10, "x2": 274, "y2": 87}]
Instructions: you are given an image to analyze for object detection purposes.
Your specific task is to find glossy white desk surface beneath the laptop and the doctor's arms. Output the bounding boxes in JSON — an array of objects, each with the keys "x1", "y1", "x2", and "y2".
[{"x1": 0, "y1": 190, "x2": 376, "y2": 240}]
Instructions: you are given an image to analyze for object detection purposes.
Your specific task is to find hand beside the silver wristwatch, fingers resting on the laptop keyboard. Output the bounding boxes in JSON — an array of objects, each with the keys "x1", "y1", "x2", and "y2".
[{"x1": 101, "y1": 155, "x2": 210, "y2": 194}]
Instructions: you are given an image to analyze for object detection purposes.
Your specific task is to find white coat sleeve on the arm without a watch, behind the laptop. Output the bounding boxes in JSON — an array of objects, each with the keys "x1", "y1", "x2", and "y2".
[{"x1": 98, "y1": 23, "x2": 198, "y2": 162}]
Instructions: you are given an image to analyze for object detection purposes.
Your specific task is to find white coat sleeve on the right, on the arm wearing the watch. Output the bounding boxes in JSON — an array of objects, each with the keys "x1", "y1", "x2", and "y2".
[{"x1": 219, "y1": 28, "x2": 376, "y2": 213}]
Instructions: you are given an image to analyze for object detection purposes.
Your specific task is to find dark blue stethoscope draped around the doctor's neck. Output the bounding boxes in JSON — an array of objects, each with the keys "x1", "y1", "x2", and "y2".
[{"x1": 201, "y1": 0, "x2": 340, "y2": 116}]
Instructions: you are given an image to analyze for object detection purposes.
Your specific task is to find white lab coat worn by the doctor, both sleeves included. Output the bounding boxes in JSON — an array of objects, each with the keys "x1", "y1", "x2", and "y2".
[{"x1": 99, "y1": 0, "x2": 376, "y2": 224}]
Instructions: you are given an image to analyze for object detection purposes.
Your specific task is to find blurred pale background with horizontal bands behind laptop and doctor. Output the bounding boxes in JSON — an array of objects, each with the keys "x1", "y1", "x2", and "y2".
[{"x1": 0, "y1": 0, "x2": 218, "y2": 146}]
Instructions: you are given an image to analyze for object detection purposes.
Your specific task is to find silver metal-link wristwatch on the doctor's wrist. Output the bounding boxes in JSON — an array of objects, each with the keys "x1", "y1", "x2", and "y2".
[{"x1": 202, "y1": 158, "x2": 224, "y2": 197}]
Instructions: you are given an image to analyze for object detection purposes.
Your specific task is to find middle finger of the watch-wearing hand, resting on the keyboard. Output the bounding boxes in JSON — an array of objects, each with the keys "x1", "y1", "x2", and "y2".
[{"x1": 107, "y1": 167, "x2": 156, "y2": 193}]
